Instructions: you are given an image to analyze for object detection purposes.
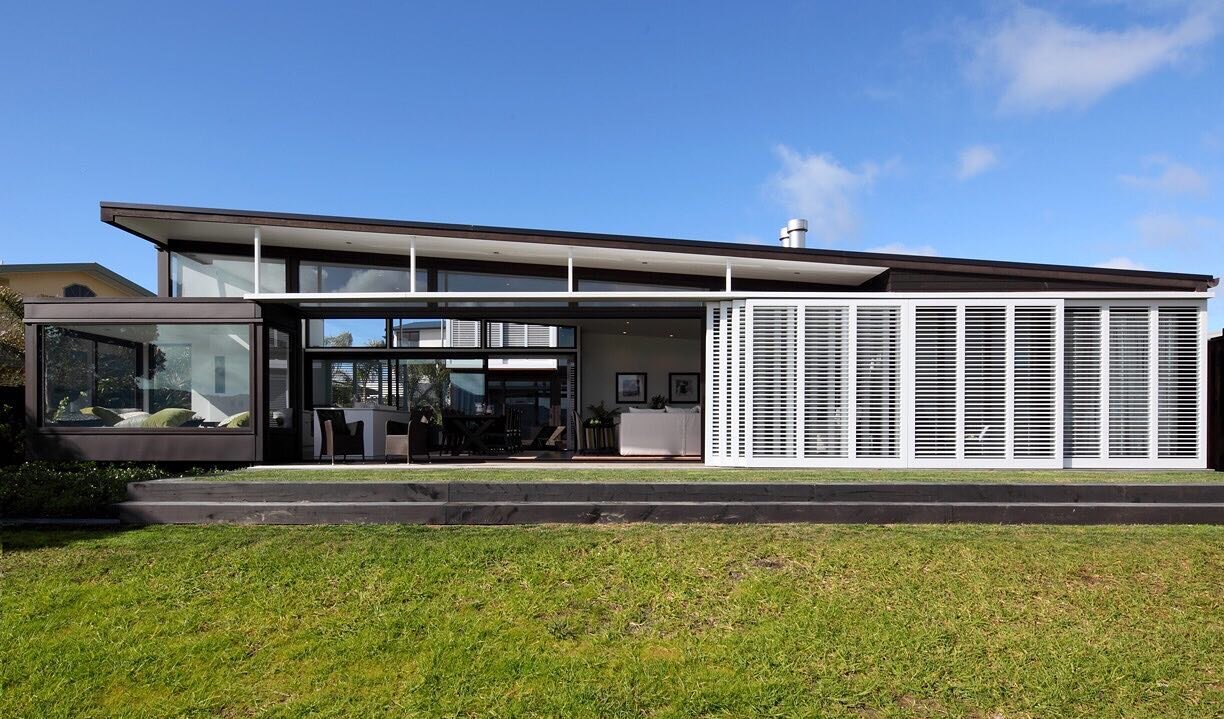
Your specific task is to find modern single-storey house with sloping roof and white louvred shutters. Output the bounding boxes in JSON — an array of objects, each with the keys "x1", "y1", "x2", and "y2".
[{"x1": 19, "y1": 202, "x2": 1217, "y2": 468}]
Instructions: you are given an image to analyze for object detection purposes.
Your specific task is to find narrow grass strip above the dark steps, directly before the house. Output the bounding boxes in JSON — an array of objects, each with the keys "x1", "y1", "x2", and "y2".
[{"x1": 207, "y1": 463, "x2": 1224, "y2": 484}]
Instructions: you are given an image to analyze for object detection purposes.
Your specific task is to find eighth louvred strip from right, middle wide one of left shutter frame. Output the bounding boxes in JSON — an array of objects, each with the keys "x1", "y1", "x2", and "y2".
[{"x1": 803, "y1": 306, "x2": 849, "y2": 457}]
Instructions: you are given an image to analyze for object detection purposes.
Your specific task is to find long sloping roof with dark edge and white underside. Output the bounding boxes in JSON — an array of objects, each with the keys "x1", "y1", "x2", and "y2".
[{"x1": 100, "y1": 202, "x2": 1218, "y2": 292}]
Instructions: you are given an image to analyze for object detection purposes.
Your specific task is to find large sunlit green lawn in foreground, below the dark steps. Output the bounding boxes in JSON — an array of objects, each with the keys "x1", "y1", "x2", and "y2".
[{"x1": 0, "y1": 525, "x2": 1224, "y2": 719}]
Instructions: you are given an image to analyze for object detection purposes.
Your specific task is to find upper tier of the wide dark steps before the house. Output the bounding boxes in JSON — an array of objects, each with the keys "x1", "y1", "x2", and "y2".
[{"x1": 127, "y1": 480, "x2": 1224, "y2": 503}]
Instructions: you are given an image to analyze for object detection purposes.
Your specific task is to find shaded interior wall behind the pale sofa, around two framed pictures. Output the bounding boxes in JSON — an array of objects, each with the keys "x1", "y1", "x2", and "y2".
[{"x1": 579, "y1": 320, "x2": 705, "y2": 416}]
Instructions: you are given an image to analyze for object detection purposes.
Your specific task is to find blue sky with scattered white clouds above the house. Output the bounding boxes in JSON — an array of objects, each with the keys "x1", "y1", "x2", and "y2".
[{"x1": 0, "y1": 0, "x2": 1224, "y2": 328}]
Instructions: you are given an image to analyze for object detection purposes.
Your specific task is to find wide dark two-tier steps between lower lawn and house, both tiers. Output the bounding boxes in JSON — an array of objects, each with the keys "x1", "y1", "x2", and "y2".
[{"x1": 119, "y1": 480, "x2": 1224, "y2": 524}]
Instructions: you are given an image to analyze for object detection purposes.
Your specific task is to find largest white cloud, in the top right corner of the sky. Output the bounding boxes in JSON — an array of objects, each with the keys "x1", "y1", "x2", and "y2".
[{"x1": 972, "y1": 5, "x2": 1219, "y2": 111}]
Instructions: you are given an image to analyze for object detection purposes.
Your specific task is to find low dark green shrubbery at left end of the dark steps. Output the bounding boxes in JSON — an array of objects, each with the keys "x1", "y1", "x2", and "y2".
[{"x1": 0, "y1": 462, "x2": 222, "y2": 517}]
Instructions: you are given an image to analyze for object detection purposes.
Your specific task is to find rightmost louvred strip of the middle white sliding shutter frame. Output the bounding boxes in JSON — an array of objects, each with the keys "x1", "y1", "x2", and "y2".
[{"x1": 1012, "y1": 305, "x2": 1058, "y2": 459}]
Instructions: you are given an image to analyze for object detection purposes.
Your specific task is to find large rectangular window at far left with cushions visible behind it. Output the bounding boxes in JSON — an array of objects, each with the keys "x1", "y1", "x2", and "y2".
[{"x1": 39, "y1": 325, "x2": 251, "y2": 429}]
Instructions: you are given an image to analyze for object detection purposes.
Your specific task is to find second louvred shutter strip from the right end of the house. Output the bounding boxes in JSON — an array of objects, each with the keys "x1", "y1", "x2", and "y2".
[{"x1": 1109, "y1": 306, "x2": 1152, "y2": 458}]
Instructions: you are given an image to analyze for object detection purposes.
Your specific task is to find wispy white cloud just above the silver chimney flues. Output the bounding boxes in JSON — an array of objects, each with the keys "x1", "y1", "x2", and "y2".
[{"x1": 769, "y1": 145, "x2": 895, "y2": 243}]
